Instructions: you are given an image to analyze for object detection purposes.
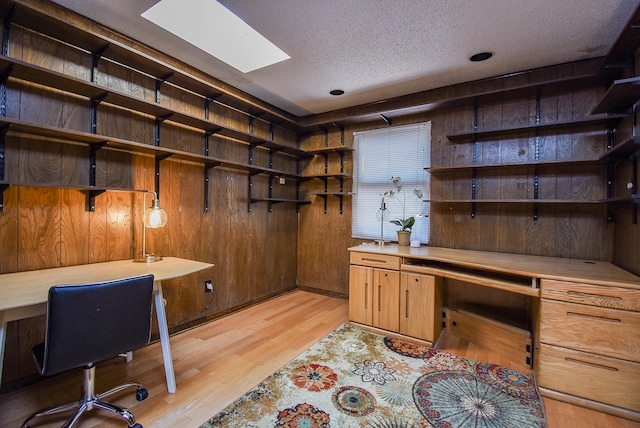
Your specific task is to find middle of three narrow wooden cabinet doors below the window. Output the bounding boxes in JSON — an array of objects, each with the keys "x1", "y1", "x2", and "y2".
[{"x1": 373, "y1": 269, "x2": 400, "y2": 332}]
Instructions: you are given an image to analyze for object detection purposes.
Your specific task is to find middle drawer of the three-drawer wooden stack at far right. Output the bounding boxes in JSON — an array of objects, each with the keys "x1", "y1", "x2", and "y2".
[{"x1": 540, "y1": 299, "x2": 640, "y2": 362}]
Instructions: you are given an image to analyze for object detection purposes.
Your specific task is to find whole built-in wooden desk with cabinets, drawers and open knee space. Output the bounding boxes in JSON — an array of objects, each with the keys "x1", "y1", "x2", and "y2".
[{"x1": 349, "y1": 243, "x2": 640, "y2": 420}]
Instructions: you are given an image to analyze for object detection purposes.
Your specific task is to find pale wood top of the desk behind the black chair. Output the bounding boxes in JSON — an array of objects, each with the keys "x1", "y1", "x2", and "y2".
[{"x1": 0, "y1": 257, "x2": 213, "y2": 311}]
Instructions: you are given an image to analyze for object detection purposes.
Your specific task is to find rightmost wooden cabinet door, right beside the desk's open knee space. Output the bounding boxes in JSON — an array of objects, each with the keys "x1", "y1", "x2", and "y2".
[{"x1": 400, "y1": 273, "x2": 439, "y2": 342}]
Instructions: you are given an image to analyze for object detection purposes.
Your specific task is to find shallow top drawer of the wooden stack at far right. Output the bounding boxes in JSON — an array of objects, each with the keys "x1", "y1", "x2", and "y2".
[{"x1": 540, "y1": 279, "x2": 640, "y2": 311}]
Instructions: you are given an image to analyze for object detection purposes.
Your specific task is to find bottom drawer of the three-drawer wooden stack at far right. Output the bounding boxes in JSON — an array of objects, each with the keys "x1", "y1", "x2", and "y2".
[{"x1": 537, "y1": 344, "x2": 640, "y2": 412}]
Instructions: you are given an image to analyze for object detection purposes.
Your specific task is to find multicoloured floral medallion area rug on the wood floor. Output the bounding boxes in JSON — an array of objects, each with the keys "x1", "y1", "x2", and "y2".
[{"x1": 201, "y1": 323, "x2": 547, "y2": 428}]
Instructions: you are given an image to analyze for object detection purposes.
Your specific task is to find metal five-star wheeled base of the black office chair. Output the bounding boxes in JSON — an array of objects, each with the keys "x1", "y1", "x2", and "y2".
[{"x1": 22, "y1": 365, "x2": 148, "y2": 428}]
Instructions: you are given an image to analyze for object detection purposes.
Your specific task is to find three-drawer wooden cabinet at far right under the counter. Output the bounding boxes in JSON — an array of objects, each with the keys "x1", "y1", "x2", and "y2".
[{"x1": 538, "y1": 280, "x2": 640, "y2": 412}]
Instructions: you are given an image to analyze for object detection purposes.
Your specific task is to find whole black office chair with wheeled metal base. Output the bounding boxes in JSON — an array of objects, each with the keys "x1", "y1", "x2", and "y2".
[{"x1": 22, "y1": 275, "x2": 153, "y2": 428}]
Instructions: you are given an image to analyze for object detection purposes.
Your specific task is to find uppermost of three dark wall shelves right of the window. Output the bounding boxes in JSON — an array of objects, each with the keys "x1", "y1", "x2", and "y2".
[{"x1": 447, "y1": 115, "x2": 624, "y2": 142}]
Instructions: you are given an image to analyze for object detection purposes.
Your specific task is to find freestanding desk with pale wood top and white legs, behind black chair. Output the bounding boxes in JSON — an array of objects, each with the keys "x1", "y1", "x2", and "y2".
[{"x1": 0, "y1": 257, "x2": 213, "y2": 393}]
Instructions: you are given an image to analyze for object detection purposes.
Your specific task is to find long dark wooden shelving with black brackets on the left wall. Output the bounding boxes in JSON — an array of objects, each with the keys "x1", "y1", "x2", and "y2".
[{"x1": 0, "y1": 0, "x2": 312, "y2": 211}]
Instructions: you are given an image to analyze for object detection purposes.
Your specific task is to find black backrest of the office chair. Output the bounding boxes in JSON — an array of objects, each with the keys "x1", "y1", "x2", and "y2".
[{"x1": 39, "y1": 275, "x2": 153, "y2": 375}]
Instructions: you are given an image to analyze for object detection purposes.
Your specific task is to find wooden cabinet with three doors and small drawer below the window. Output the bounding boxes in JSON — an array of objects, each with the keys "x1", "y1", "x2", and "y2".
[{"x1": 349, "y1": 252, "x2": 443, "y2": 343}]
